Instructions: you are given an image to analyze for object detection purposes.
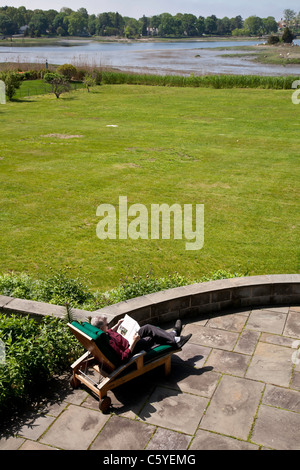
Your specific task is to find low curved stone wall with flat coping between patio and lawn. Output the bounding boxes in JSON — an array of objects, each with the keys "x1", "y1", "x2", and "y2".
[{"x1": 0, "y1": 274, "x2": 300, "y2": 325}]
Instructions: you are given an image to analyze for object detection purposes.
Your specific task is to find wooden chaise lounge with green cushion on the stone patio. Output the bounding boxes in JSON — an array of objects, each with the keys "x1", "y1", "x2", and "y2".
[{"x1": 68, "y1": 321, "x2": 181, "y2": 411}]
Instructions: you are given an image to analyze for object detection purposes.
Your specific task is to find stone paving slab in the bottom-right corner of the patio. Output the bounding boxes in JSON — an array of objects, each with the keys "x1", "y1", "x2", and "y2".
[{"x1": 251, "y1": 405, "x2": 300, "y2": 450}]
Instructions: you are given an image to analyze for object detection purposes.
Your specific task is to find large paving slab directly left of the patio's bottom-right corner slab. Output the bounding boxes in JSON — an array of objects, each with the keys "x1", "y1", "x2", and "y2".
[{"x1": 200, "y1": 375, "x2": 264, "y2": 440}]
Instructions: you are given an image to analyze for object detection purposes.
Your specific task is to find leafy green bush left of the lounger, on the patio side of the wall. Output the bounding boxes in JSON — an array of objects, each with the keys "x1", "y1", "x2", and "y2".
[{"x1": 0, "y1": 314, "x2": 82, "y2": 412}]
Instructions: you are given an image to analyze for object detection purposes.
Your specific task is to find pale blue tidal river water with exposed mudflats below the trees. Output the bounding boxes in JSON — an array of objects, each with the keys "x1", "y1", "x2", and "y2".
[{"x1": 0, "y1": 39, "x2": 300, "y2": 75}]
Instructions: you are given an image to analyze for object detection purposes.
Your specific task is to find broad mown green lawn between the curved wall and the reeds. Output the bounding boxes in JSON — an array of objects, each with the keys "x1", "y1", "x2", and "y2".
[{"x1": 0, "y1": 85, "x2": 300, "y2": 289}]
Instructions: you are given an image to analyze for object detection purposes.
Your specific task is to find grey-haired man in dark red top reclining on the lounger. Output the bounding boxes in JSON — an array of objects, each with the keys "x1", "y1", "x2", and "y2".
[{"x1": 91, "y1": 315, "x2": 192, "y2": 362}]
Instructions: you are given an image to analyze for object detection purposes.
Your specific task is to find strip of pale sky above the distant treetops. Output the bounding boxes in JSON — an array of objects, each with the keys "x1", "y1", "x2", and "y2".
[{"x1": 0, "y1": 0, "x2": 300, "y2": 21}]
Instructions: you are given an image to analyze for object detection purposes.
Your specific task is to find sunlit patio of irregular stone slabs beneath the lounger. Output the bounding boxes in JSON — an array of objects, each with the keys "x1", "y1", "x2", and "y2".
[{"x1": 0, "y1": 306, "x2": 300, "y2": 451}]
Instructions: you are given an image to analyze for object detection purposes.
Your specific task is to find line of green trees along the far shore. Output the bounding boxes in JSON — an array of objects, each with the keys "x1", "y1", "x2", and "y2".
[{"x1": 0, "y1": 6, "x2": 286, "y2": 38}]
